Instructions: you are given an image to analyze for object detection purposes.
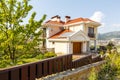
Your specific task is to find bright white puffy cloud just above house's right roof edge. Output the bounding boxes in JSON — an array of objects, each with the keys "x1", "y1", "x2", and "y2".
[{"x1": 90, "y1": 11, "x2": 105, "y2": 22}]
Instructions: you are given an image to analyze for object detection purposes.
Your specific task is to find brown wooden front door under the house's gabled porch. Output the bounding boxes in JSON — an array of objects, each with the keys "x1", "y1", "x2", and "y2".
[{"x1": 73, "y1": 42, "x2": 82, "y2": 54}]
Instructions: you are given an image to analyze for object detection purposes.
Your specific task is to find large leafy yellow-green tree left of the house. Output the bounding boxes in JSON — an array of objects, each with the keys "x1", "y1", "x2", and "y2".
[{"x1": 0, "y1": 0, "x2": 46, "y2": 63}]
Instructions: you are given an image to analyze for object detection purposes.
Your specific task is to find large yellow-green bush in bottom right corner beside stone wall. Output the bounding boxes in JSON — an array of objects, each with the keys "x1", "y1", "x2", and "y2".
[{"x1": 88, "y1": 53, "x2": 120, "y2": 80}]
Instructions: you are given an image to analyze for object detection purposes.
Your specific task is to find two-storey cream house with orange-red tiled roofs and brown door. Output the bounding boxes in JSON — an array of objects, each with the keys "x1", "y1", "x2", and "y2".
[{"x1": 43, "y1": 15, "x2": 101, "y2": 54}]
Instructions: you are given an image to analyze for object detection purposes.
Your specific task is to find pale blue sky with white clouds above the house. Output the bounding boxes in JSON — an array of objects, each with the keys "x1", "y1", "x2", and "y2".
[{"x1": 27, "y1": 0, "x2": 120, "y2": 33}]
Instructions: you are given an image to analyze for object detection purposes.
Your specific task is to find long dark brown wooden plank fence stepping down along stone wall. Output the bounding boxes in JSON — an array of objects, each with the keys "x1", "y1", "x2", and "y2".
[{"x1": 0, "y1": 54, "x2": 102, "y2": 80}]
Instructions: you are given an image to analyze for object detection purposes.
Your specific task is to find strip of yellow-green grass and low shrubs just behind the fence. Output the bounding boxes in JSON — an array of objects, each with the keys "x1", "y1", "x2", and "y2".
[{"x1": 0, "y1": 52, "x2": 57, "y2": 69}]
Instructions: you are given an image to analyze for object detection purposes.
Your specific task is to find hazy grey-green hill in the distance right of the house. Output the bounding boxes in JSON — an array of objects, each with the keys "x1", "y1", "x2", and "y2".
[{"x1": 98, "y1": 31, "x2": 120, "y2": 40}]
